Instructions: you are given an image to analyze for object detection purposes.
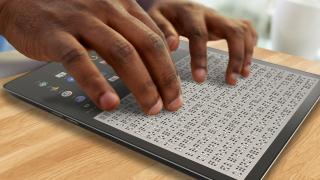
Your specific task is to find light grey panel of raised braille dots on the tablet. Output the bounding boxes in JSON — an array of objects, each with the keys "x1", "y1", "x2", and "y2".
[{"x1": 94, "y1": 52, "x2": 318, "y2": 179}]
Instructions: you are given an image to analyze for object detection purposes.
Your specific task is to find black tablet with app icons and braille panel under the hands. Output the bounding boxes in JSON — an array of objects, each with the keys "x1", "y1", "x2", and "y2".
[{"x1": 4, "y1": 42, "x2": 320, "y2": 180}]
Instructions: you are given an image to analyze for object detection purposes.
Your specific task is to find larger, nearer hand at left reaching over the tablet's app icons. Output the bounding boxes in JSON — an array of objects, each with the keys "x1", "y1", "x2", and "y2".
[{"x1": 0, "y1": 0, "x2": 182, "y2": 114}]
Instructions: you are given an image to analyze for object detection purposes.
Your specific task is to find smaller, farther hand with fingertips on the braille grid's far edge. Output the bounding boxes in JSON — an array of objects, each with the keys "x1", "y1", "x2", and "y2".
[{"x1": 148, "y1": 0, "x2": 257, "y2": 85}]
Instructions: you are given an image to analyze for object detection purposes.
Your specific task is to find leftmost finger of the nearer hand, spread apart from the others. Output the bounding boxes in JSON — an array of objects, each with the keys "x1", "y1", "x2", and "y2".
[{"x1": 47, "y1": 32, "x2": 120, "y2": 110}]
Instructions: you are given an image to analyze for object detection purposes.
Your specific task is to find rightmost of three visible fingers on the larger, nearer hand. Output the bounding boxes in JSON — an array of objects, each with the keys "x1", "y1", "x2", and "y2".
[{"x1": 110, "y1": 13, "x2": 183, "y2": 111}]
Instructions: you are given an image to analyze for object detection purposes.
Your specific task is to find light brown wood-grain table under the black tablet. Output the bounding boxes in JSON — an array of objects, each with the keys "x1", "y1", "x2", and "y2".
[{"x1": 0, "y1": 42, "x2": 320, "y2": 180}]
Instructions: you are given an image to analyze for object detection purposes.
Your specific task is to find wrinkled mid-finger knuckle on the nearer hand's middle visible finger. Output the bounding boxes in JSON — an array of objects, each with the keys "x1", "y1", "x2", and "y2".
[{"x1": 111, "y1": 40, "x2": 135, "y2": 64}]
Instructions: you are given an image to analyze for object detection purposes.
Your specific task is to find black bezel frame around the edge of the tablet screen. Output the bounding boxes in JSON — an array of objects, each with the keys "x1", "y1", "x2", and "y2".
[{"x1": 4, "y1": 41, "x2": 320, "y2": 180}]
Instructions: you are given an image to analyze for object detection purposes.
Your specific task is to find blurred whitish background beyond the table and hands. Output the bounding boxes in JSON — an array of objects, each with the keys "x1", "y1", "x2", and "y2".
[{"x1": 0, "y1": 0, "x2": 320, "y2": 60}]
